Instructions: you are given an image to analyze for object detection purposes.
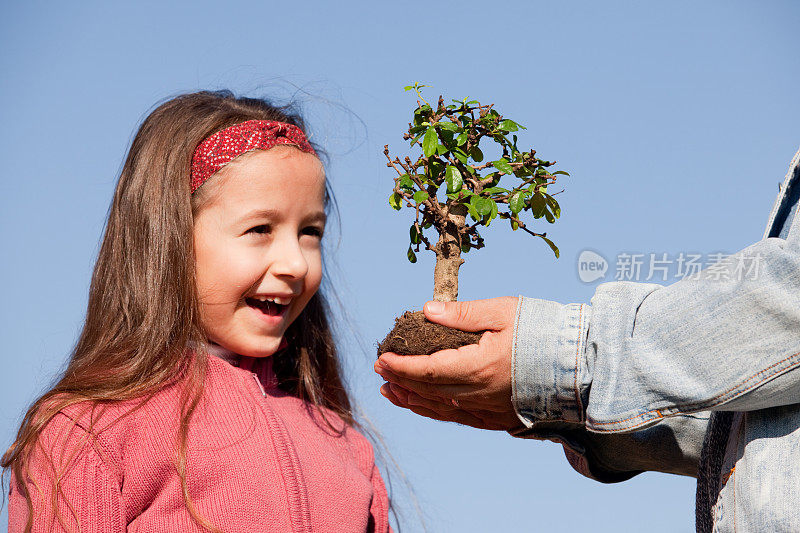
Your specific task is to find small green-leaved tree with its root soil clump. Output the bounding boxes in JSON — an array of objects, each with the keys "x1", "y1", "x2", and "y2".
[{"x1": 378, "y1": 83, "x2": 569, "y2": 354}]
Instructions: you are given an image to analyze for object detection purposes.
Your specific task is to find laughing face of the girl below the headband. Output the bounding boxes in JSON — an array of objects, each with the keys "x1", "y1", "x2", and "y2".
[{"x1": 194, "y1": 146, "x2": 325, "y2": 357}]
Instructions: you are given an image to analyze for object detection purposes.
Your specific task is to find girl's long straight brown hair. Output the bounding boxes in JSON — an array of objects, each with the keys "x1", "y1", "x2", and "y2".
[{"x1": 0, "y1": 91, "x2": 354, "y2": 531}]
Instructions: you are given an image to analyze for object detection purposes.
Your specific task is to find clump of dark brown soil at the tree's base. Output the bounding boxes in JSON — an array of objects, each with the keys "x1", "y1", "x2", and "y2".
[{"x1": 378, "y1": 311, "x2": 483, "y2": 355}]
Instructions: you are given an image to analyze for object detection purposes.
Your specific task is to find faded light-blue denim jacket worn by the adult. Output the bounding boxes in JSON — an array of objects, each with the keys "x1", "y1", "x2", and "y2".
[{"x1": 512, "y1": 147, "x2": 800, "y2": 532}]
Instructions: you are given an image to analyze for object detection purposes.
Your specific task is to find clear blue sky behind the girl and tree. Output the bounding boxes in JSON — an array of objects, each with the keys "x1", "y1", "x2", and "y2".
[{"x1": 0, "y1": 0, "x2": 800, "y2": 532}]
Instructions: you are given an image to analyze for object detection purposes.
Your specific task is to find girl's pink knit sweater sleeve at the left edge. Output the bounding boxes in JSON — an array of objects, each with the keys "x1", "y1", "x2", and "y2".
[{"x1": 8, "y1": 414, "x2": 125, "y2": 533}]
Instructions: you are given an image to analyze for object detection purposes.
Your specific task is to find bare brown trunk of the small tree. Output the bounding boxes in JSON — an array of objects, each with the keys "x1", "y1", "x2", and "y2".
[{"x1": 433, "y1": 205, "x2": 467, "y2": 302}]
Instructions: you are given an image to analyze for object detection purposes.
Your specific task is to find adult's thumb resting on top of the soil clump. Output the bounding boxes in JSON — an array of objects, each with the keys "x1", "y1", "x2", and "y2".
[{"x1": 423, "y1": 296, "x2": 518, "y2": 331}]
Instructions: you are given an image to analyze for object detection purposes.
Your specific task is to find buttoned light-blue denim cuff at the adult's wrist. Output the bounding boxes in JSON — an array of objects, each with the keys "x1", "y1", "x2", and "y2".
[{"x1": 511, "y1": 296, "x2": 592, "y2": 428}]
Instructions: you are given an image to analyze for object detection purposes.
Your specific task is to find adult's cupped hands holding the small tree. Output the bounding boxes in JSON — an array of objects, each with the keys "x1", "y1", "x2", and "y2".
[{"x1": 375, "y1": 297, "x2": 521, "y2": 430}]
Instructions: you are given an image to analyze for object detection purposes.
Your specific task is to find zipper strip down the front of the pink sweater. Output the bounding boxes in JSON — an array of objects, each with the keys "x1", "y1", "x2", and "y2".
[{"x1": 251, "y1": 372, "x2": 312, "y2": 533}]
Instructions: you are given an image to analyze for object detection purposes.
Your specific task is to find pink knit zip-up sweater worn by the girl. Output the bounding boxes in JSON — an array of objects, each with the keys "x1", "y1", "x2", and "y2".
[{"x1": 9, "y1": 350, "x2": 390, "y2": 533}]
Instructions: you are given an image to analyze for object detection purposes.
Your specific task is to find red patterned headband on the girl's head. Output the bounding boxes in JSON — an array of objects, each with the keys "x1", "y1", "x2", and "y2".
[{"x1": 192, "y1": 120, "x2": 317, "y2": 192}]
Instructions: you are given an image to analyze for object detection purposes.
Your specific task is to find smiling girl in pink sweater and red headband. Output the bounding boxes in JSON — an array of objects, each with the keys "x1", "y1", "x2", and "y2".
[{"x1": 2, "y1": 92, "x2": 390, "y2": 533}]
